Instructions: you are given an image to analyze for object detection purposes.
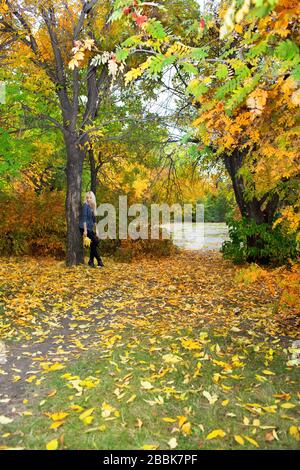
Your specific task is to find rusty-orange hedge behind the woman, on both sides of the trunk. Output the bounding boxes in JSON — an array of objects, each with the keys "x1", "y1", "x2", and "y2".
[{"x1": 0, "y1": 191, "x2": 175, "y2": 262}]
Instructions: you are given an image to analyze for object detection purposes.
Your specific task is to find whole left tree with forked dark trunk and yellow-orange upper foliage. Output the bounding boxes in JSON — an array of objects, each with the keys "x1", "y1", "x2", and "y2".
[{"x1": 0, "y1": 0, "x2": 119, "y2": 265}]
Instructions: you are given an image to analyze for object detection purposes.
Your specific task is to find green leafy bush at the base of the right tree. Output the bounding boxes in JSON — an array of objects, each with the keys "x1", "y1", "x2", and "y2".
[{"x1": 221, "y1": 218, "x2": 299, "y2": 266}]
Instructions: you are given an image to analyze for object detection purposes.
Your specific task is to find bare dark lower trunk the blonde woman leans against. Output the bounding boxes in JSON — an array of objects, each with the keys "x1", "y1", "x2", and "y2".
[{"x1": 65, "y1": 134, "x2": 84, "y2": 266}]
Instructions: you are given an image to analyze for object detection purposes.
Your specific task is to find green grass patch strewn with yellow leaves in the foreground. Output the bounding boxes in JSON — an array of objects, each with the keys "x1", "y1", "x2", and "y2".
[{"x1": 0, "y1": 327, "x2": 299, "y2": 450}]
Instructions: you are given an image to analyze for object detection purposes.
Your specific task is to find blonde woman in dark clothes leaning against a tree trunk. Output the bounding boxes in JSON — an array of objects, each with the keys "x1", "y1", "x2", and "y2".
[{"x1": 79, "y1": 191, "x2": 104, "y2": 268}]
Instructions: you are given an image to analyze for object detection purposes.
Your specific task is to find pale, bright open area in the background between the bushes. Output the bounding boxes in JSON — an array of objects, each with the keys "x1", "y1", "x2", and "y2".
[{"x1": 162, "y1": 222, "x2": 229, "y2": 250}]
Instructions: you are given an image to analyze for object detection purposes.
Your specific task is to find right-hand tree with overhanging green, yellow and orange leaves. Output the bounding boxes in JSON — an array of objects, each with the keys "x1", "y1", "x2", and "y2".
[{"x1": 78, "y1": 0, "x2": 300, "y2": 260}]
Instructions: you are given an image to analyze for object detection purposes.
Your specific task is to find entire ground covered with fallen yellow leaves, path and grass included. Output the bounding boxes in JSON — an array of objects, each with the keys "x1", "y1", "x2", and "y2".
[{"x1": 0, "y1": 252, "x2": 300, "y2": 449}]
